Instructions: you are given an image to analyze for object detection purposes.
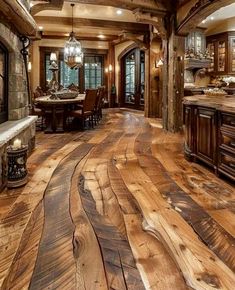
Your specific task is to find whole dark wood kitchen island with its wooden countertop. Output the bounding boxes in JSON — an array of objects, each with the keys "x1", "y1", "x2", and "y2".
[{"x1": 183, "y1": 95, "x2": 235, "y2": 181}]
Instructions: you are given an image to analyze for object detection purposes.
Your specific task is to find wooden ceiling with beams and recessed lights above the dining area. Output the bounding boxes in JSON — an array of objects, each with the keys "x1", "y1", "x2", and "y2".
[{"x1": 31, "y1": 0, "x2": 194, "y2": 41}]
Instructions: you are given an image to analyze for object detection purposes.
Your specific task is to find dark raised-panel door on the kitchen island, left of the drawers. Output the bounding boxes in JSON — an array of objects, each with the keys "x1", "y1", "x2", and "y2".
[{"x1": 196, "y1": 107, "x2": 216, "y2": 165}]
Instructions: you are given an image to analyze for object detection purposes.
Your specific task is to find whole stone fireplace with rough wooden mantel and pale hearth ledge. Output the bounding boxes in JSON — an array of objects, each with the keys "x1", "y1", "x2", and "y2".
[{"x1": 0, "y1": 1, "x2": 36, "y2": 190}]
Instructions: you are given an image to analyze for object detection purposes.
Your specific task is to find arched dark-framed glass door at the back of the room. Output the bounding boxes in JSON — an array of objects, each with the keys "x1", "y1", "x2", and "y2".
[{"x1": 120, "y1": 48, "x2": 145, "y2": 110}]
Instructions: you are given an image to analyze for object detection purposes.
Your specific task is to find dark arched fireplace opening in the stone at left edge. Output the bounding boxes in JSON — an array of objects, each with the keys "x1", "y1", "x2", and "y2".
[{"x1": 0, "y1": 43, "x2": 8, "y2": 123}]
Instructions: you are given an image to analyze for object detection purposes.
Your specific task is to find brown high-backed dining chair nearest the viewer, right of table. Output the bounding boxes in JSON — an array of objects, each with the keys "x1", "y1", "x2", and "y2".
[{"x1": 68, "y1": 89, "x2": 98, "y2": 129}]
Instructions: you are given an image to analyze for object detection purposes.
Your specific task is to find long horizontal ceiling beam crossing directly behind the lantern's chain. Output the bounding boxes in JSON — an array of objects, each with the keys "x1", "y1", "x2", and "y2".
[{"x1": 34, "y1": 16, "x2": 149, "y2": 33}]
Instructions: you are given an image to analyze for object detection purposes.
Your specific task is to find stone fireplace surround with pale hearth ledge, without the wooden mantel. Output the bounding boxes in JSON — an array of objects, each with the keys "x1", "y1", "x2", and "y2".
[{"x1": 0, "y1": 19, "x2": 36, "y2": 191}]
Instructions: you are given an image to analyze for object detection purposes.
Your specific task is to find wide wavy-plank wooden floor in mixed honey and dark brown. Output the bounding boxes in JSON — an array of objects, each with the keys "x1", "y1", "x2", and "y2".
[{"x1": 0, "y1": 109, "x2": 235, "y2": 290}]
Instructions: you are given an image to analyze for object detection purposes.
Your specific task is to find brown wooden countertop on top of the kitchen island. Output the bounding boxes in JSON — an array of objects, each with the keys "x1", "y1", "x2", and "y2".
[{"x1": 183, "y1": 95, "x2": 235, "y2": 113}]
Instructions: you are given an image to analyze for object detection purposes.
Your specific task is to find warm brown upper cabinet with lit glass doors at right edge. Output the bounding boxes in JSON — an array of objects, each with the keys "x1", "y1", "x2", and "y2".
[{"x1": 206, "y1": 32, "x2": 235, "y2": 74}]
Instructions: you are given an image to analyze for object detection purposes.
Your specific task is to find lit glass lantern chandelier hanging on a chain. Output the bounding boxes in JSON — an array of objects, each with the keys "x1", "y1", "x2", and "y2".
[{"x1": 64, "y1": 4, "x2": 83, "y2": 69}]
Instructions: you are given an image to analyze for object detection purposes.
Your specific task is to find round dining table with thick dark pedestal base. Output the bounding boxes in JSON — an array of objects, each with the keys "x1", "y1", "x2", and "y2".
[{"x1": 35, "y1": 93, "x2": 85, "y2": 133}]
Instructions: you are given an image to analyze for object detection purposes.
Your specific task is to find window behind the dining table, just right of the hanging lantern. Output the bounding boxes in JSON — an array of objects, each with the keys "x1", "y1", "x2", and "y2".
[{"x1": 84, "y1": 56, "x2": 103, "y2": 89}]
